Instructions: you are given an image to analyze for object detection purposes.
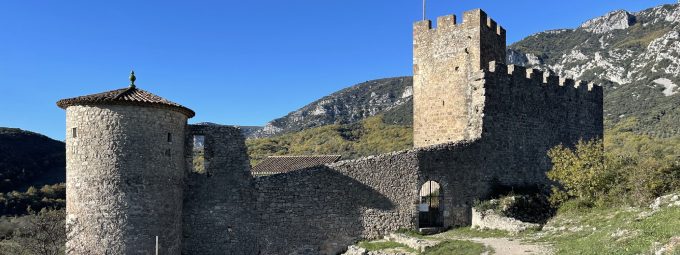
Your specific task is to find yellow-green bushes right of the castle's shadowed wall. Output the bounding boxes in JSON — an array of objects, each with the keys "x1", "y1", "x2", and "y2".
[{"x1": 548, "y1": 118, "x2": 680, "y2": 206}]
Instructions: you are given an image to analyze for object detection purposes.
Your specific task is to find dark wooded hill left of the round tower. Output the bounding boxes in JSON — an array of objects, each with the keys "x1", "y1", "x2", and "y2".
[{"x1": 0, "y1": 127, "x2": 66, "y2": 192}]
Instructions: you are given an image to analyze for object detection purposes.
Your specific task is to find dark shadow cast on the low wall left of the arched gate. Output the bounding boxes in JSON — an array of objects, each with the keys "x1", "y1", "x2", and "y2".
[{"x1": 255, "y1": 166, "x2": 395, "y2": 254}]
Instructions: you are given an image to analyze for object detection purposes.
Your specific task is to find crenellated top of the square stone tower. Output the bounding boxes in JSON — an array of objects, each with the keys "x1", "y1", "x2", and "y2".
[{"x1": 414, "y1": 9, "x2": 505, "y2": 38}]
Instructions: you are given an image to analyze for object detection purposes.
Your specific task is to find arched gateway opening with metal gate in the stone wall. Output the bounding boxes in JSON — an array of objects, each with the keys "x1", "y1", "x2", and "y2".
[{"x1": 418, "y1": 181, "x2": 444, "y2": 228}]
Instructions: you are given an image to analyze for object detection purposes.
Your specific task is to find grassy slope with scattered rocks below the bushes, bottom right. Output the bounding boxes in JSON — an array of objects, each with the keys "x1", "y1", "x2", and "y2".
[{"x1": 527, "y1": 202, "x2": 680, "y2": 254}]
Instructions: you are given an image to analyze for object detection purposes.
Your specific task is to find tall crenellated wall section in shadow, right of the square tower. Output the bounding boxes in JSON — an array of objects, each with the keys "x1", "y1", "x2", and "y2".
[{"x1": 482, "y1": 62, "x2": 603, "y2": 186}]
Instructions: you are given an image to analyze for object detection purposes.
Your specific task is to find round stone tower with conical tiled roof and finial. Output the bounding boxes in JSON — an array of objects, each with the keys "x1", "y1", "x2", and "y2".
[{"x1": 57, "y1": 72, "x2": 194, "y2": 254}]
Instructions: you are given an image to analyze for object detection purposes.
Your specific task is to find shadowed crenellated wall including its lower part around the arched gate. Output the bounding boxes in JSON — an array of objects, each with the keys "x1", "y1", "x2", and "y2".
[{"x1": 418, "y1": 62, "x2": 603, "y2": 226}]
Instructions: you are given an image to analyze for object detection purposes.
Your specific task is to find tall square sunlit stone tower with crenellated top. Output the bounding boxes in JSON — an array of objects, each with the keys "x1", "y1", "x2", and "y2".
[{"x1": 413, "y1": 9, "x2": 506, "y2": 147}]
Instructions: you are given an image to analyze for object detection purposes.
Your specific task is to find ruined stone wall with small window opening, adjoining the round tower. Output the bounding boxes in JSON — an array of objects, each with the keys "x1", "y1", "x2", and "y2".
[{"x1": 182, "y1": 125, "x2": 258, "y2": 254}]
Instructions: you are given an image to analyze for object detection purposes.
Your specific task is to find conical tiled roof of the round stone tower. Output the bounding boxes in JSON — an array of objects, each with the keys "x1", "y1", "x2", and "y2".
[{"x1": 57, "y1": 86, "x2": 196, "y2": 118}]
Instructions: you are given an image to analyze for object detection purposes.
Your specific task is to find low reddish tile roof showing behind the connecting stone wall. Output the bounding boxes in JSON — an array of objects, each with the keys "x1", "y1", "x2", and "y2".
[{"x1": 252, "y1": 155, "x2": 341, "y2": 175}]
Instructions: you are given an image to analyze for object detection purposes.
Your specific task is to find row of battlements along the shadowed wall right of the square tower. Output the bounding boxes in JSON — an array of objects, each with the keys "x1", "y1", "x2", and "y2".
[{"x1": 489, "y1": 61, "x2": 602, "y2": 98}]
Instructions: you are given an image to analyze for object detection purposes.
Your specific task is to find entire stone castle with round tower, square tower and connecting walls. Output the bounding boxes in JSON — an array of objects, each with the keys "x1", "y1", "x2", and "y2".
[{"x1": 57, "y1": 10, "x2": 603, "y2": 254}]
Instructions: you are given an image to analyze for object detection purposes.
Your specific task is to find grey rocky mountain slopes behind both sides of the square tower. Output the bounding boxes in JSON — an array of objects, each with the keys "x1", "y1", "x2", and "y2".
[{"x1": 248, "y1": 4, "x2": 680, "y2": 138}]
